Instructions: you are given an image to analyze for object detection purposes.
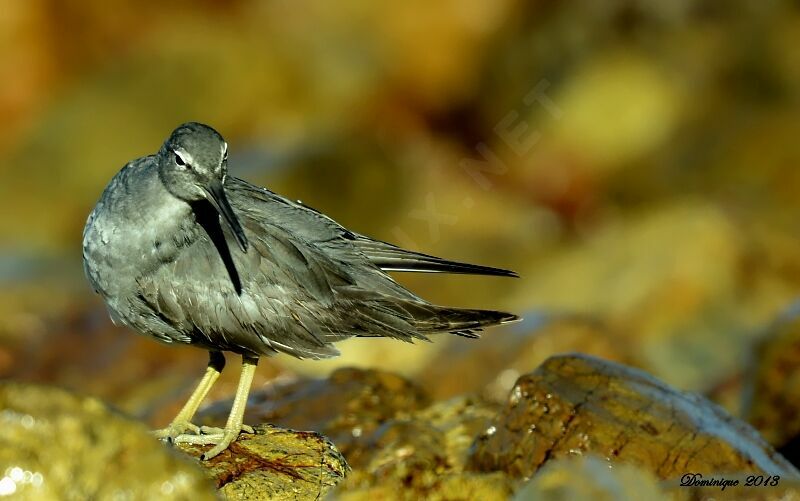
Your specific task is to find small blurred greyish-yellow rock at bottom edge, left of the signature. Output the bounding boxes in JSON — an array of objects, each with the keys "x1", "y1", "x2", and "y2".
[{"x1": 514, "y1": 454, "x2": 672, "y2": 501}]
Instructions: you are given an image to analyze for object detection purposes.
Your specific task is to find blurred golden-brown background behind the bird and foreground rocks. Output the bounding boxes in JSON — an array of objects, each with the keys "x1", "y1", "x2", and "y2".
[{"x1": 0, "y1": 0, "x2": 800, "y2": 438}]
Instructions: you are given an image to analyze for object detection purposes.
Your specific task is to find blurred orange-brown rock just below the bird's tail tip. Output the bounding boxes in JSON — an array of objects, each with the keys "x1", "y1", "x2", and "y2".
[{"x1": 419, "y1": 313, "x2": 631, "y2": 402}]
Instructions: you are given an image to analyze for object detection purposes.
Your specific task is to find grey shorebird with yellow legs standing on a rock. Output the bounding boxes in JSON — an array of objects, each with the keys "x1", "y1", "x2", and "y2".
[{"x1": 83, "y1": 122, "x2": 518, "y2": 459}]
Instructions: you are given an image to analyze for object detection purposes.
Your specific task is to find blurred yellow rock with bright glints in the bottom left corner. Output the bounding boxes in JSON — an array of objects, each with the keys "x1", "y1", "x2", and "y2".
[{"x1": 0, "y1": 382, "x2": 216, "y2": 500}]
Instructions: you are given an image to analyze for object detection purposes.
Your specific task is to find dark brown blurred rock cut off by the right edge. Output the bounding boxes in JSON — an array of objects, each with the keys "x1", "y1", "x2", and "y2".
[{"x1": 746, "y1": 305, "x2": 800, "y2": 450}]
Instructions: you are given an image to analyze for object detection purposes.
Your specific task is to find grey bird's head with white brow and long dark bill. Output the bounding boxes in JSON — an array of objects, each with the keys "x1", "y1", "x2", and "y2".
[{"x1": 156, "y1": 122, "x2": 247, "y2": 252}]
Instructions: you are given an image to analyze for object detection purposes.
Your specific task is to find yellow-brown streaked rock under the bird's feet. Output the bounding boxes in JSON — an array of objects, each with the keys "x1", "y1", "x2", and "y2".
[{"x1": 178, "y1": 425, "x2": 350, "y2": 500}]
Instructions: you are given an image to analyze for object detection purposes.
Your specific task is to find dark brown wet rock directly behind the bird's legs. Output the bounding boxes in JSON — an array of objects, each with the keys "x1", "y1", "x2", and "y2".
[{"x1": 199, "y1": 369, "x2": 429, "y2": 465}]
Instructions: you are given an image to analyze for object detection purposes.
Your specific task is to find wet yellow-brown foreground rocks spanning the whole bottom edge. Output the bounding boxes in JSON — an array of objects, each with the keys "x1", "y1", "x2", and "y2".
[{"x1": 0, "y1": 355, "x2": 800, "y2": 500}]
